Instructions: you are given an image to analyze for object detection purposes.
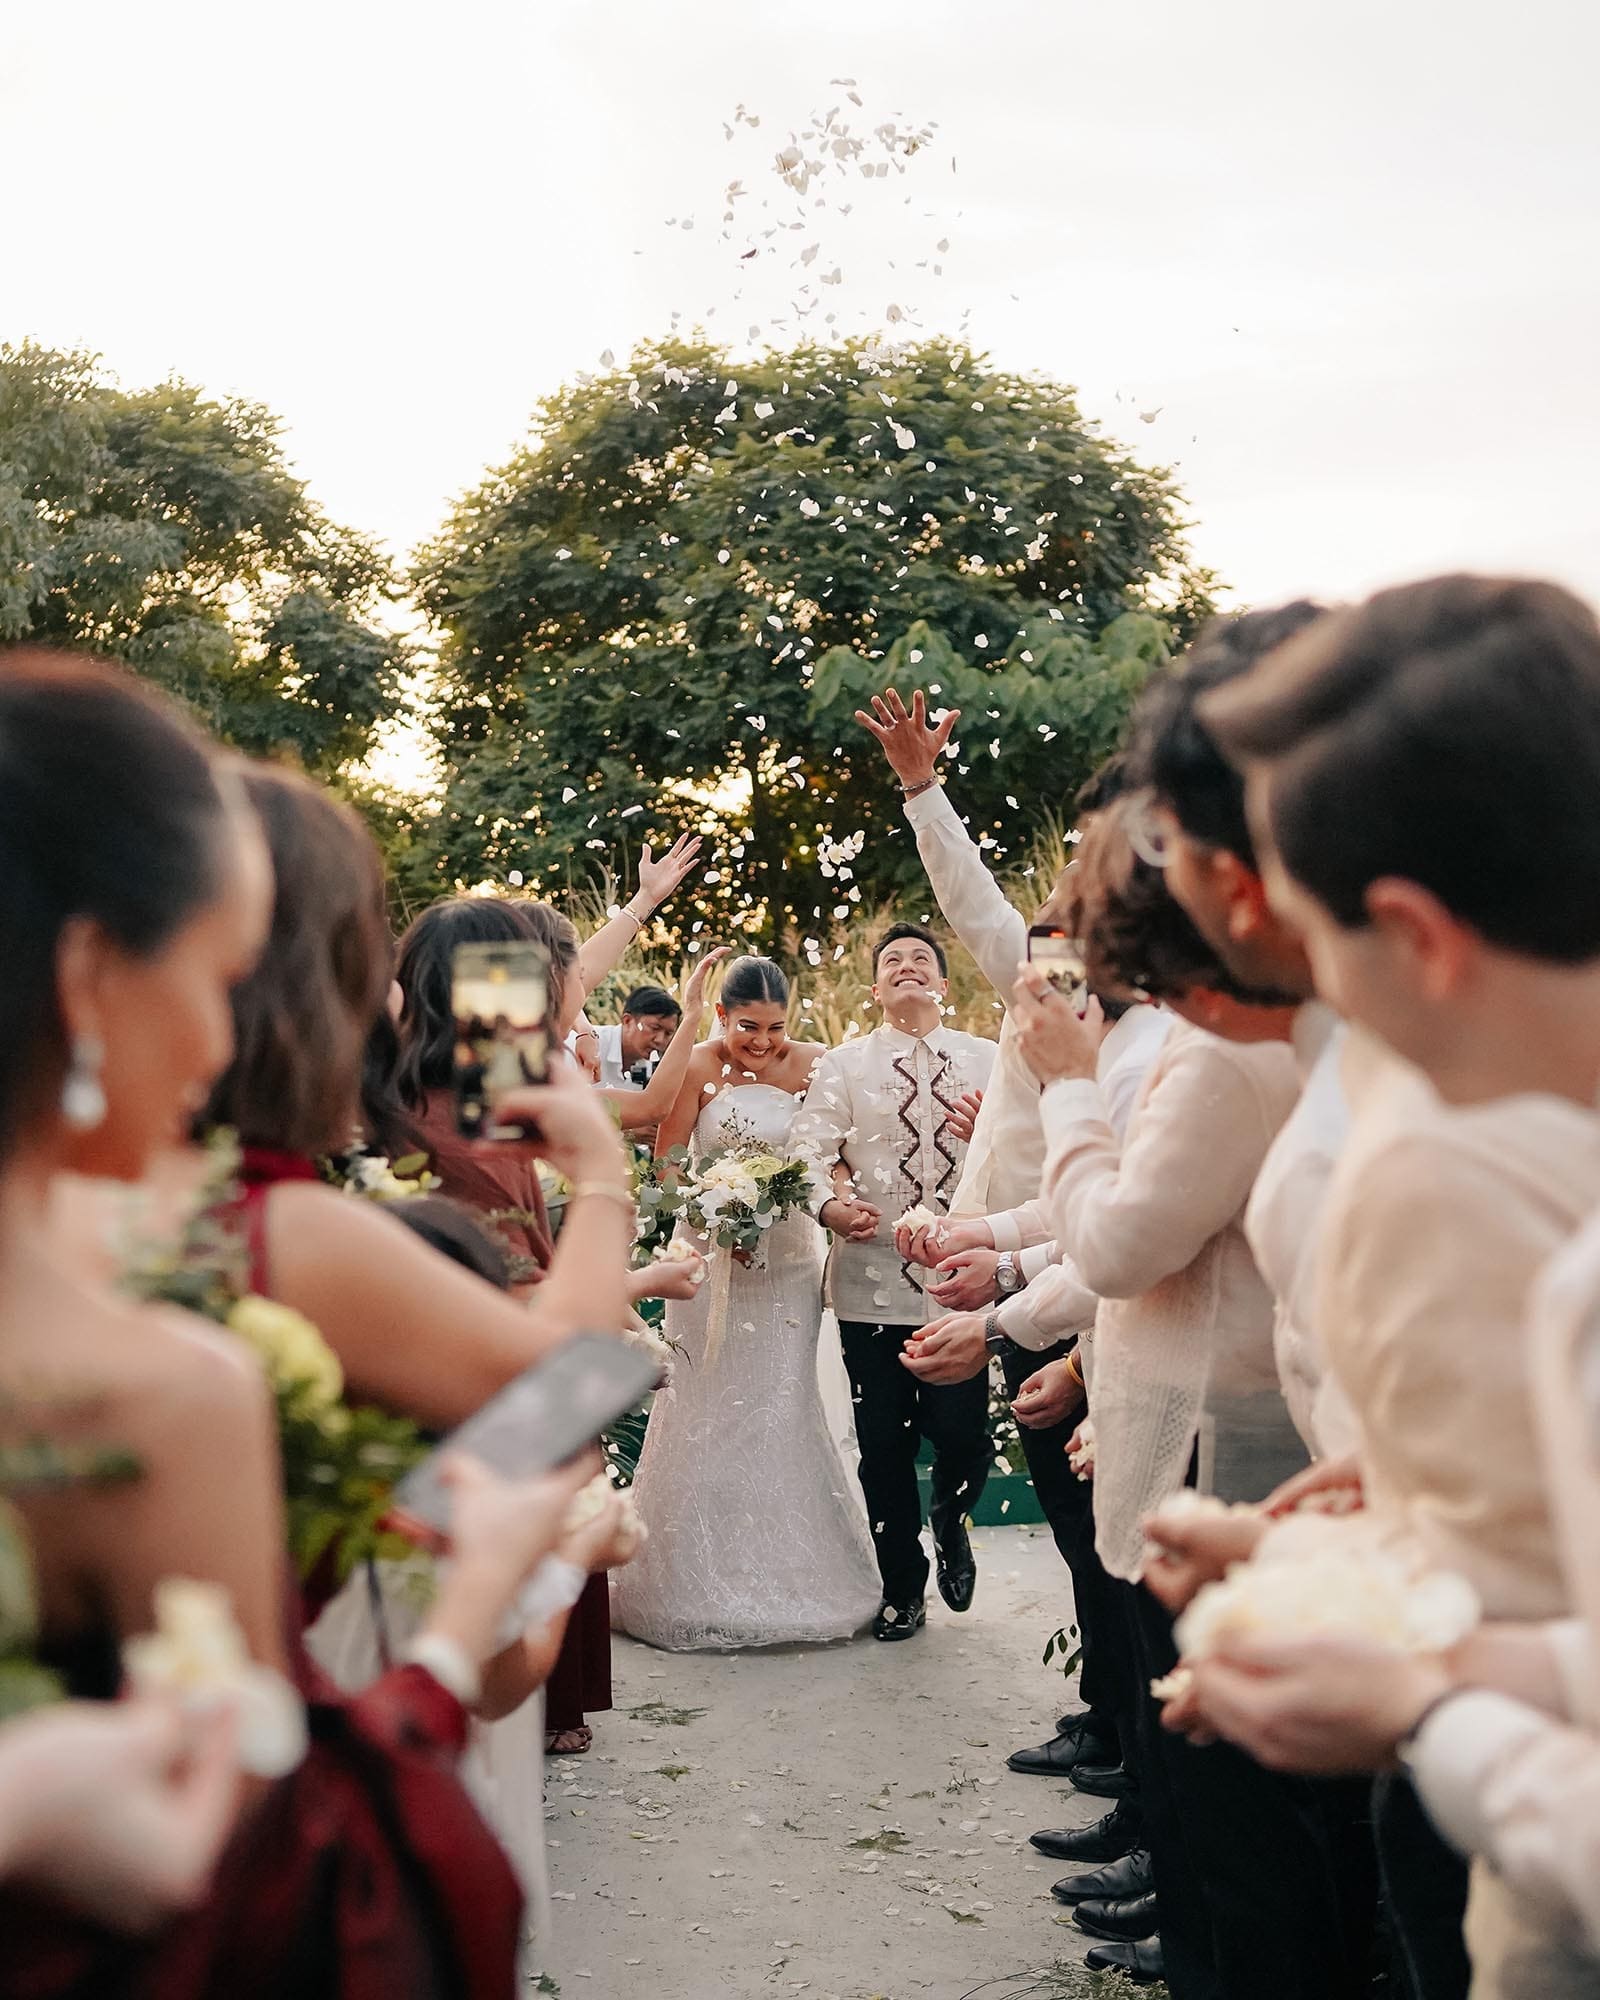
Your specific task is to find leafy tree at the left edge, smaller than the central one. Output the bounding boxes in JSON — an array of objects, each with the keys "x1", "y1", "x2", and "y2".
[{"x1": 0, "y1": 342, "x2": 404, "y2": 772}]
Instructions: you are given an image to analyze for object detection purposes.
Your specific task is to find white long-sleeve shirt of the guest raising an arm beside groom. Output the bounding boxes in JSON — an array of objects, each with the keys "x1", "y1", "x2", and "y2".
[{"x1": 906, "y1": 784, "x2": 1044, "y2": 1216}]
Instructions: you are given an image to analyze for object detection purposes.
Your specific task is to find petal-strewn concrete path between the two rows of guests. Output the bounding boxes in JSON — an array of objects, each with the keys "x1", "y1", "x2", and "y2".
[{"x1": 540, "y1": 1528, "x2": 1152, "y2": 2000}]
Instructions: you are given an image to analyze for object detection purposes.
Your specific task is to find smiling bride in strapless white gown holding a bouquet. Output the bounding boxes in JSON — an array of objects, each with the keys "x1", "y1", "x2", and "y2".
[{"x1": 614, "y1": 958, "x2": 880, "y2": 1652}]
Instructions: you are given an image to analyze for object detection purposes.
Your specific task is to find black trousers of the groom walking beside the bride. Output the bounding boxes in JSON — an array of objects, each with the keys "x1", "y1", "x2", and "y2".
[{"x1": 840, "y1": 1320, "x2": 992, "y2": 1604}]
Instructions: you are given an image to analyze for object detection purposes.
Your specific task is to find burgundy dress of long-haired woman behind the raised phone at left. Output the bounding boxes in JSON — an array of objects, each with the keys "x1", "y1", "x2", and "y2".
[{"x1": 406, "y1": 1090, "x2": 612, "y2": 1732}]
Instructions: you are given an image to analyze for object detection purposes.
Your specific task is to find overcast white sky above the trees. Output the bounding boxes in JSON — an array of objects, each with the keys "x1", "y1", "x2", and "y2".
[{"x1": 0, "y1": 0, "x2": 1600, "y2": 602}]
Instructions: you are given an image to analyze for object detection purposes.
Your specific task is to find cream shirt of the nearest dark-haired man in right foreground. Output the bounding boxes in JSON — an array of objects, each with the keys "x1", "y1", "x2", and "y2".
[{"x1": 1316, "y1": 1068, "x2": 1600, "y2": 1620}]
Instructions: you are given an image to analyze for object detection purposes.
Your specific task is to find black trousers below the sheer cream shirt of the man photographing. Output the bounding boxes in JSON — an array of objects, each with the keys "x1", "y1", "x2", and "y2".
[{"x1": 1118, "y1": 1584, "x2": 1368, "y2": 2000}]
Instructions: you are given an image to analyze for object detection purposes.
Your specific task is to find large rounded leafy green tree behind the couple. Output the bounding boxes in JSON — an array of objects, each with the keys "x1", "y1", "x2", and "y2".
[{"x1": 418, "y1": 342, "x2": 1210, "y2": 934}]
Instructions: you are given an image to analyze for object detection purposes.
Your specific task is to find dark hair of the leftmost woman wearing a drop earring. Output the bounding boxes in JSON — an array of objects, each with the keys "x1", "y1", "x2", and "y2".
[{"x1": 0, "y1": 646, "x2": 230, "y2": 1148}]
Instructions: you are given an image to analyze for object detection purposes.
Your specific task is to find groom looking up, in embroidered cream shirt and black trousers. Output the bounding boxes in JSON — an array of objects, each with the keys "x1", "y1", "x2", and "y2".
[{"x1": 794, "y1": 924, "x2": 994, "y2": 1640}]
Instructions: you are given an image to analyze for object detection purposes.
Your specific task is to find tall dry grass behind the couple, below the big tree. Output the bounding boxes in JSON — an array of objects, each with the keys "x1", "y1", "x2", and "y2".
[{"x1": 580, "y1": 824, "x2": 1072, "y2": 1046}]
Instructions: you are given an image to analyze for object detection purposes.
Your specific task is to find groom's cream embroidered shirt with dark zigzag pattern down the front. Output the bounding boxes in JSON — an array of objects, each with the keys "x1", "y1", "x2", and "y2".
[{"x1": 792, "y1": 1022, "x2": 994, "y2": 1326}]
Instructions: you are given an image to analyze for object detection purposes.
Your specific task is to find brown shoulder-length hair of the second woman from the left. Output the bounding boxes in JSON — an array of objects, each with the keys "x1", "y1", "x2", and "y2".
[{"x1": 202, "y1": 764, "x2": 392, "y2": 1154}]
